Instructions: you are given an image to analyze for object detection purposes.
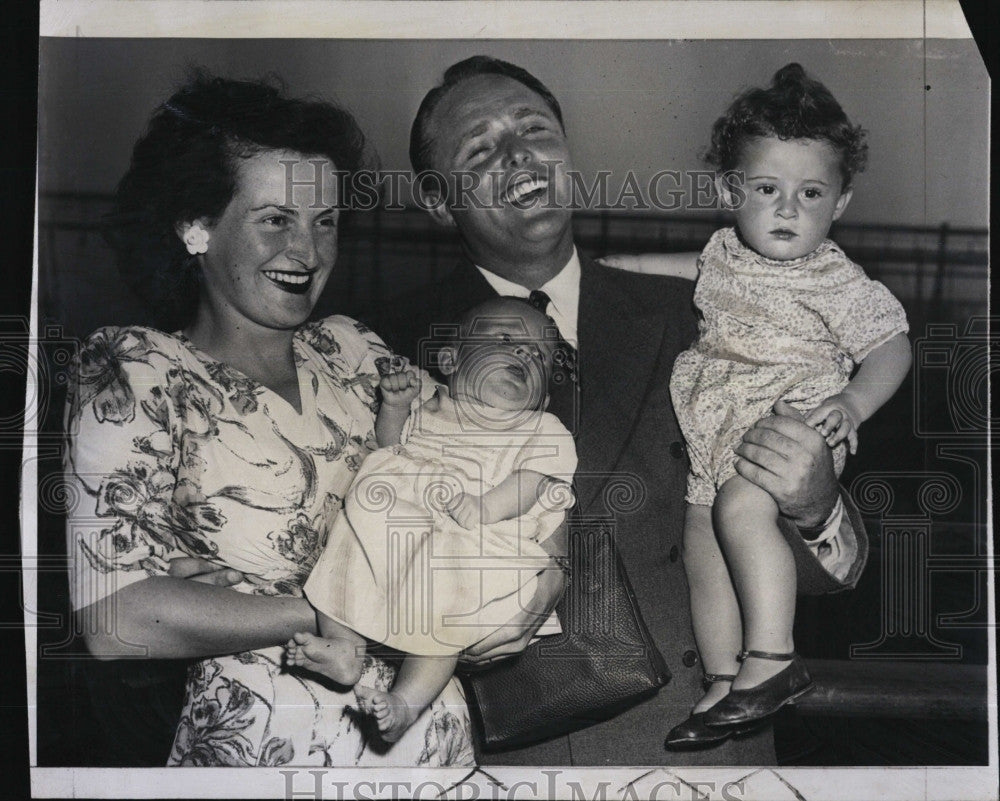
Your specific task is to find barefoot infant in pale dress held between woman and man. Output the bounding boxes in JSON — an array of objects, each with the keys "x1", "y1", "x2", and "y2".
[{"x1": 286, "y1": 298, "x2": 576, "y2": 742}]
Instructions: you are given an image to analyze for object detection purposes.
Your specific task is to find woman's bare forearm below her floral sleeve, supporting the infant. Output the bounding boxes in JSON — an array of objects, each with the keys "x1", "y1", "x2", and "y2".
[{"x1": 76, "y1": 576, "x2": 316, "y2": 660}]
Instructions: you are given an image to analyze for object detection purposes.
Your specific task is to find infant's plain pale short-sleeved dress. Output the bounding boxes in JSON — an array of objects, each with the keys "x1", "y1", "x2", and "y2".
[{"x1": 304, "y1": 388, "x2": 576, "y2": 655}]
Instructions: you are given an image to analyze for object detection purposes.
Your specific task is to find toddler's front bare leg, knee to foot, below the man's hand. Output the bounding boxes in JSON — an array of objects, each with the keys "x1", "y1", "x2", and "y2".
[{"x1": 712, "y1": 476, "x2": 795, "y2": 690}]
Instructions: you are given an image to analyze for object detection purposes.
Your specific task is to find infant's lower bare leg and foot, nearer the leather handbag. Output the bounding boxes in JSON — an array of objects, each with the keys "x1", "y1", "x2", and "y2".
[{"x1": 355, "y1": 654, "x2": 458, "y2": 743}]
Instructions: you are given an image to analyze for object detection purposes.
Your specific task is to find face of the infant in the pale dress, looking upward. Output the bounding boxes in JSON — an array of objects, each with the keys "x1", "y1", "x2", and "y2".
[{"x1": 449, "y1": 301, "x2": 556, "y2": 411}]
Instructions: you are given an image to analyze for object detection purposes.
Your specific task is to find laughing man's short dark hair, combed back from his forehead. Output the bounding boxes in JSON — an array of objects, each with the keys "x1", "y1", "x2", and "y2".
[{"x1": 410, "y1": 56, "x2": 566, "y2": 196}]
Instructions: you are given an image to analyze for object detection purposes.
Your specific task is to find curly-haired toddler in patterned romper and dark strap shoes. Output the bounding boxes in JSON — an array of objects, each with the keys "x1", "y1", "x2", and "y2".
[{"x1": 615, "y1": 64, "x2": 911, "y2": 748}]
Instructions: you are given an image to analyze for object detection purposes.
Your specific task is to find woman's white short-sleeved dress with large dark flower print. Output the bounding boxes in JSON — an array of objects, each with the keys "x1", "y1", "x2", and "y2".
[{"x1": 66, "y1": 317, "x2": 473, "y2": 767}]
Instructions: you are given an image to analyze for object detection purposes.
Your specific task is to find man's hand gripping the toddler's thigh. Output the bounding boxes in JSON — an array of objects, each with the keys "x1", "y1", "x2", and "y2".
[{"x1": 736, "y1": 401, "x2": 839, "y2": 528}]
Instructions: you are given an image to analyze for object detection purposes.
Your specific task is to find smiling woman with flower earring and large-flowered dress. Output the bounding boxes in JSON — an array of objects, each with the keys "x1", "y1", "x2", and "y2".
[{"x1": 66, "y1": 76, "x2": 473, "y2": 767}]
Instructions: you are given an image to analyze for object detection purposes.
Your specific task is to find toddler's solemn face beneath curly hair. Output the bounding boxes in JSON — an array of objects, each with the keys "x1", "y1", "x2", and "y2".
[{"x1": 736, "y1": 136, "x2": 851, "y2": 261}]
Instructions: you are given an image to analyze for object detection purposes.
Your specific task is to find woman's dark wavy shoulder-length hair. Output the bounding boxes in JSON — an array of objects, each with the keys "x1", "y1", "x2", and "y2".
[{"x1": 107, "y1": 70, "x2": 368, "y2": 330}]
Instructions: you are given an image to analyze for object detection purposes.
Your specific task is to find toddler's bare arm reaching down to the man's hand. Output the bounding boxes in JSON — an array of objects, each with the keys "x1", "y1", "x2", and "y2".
[{"x1": 806, "y1": 334, "x2": 912, "y2": 453}]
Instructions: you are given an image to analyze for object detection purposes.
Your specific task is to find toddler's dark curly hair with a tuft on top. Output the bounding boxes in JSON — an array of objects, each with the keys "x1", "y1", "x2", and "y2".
[{"x1": 704, "y1": 63, "x2": 868, "y2": 190}]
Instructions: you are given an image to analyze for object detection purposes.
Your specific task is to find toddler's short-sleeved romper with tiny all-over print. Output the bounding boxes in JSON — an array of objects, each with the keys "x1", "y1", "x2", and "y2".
[{"x1": 670, "y1": 228, "x2": 908, "y2": 506}]
